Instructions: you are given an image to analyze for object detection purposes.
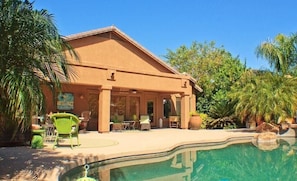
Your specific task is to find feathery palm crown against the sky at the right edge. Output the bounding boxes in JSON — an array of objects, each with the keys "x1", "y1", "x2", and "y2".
[{"x1": 256, "y1": 34, "x2": 297, "y2": 76}]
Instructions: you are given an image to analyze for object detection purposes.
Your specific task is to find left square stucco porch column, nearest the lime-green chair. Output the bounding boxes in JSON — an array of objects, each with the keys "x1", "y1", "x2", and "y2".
[{"x1": 98, "y1": 85, "x2": 112, "y2": 133}]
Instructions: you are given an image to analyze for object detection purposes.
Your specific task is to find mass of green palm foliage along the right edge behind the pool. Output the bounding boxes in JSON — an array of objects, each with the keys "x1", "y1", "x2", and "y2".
[{"x1": 229, "y1": 34, "x2": 297, "y2": 123}]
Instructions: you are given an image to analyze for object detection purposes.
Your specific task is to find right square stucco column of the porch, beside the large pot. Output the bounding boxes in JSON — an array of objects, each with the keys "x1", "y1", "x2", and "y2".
[{"x1": 181, "y1": 94, "x2": 190, "y2": 129}]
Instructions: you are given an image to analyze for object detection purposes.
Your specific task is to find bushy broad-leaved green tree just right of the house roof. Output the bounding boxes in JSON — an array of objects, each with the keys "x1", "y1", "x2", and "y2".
[{"x1": 165, "y1": 41, "x2": 245, "y2": 114}]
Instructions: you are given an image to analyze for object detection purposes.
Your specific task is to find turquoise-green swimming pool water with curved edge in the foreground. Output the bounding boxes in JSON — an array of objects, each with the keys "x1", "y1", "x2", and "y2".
[{"x1": 60, "y1": 138, "x2": 297, "y2": 181}]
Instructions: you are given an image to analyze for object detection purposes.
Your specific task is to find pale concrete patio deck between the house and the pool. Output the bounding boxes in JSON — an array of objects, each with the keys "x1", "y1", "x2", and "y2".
[{"x1": 0, "y1": 129, "x2": 256, "y2": 181}]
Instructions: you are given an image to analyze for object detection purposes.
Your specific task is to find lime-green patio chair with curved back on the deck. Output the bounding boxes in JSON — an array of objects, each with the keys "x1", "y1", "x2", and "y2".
[{"x1": 51, "y1": 113, "x2": 79, "y2": 149}]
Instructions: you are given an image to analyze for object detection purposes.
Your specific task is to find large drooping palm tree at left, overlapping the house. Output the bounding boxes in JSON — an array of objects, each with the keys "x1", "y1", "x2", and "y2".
[{"x1": 0, "y1": 0, "x2": 77, "y2": 144}]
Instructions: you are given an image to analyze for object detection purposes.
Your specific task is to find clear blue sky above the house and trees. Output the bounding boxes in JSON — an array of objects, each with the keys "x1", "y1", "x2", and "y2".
[{"x1": 34, "y1": 0, "x2": 297, "y2": 69}]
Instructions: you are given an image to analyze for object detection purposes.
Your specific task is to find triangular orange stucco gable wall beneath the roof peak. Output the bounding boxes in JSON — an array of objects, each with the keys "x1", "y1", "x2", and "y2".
[{"x1": 70, "y1": 36, "x2": 170, "y2": 73}]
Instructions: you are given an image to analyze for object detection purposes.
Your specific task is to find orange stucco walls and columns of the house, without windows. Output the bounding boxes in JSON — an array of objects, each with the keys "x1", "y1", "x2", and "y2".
[{"x1": 42, "y1": 28, "x2": 196, "y2": 132}]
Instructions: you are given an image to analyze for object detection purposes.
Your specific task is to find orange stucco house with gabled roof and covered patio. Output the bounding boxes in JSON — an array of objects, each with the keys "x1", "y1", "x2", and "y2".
[{"x1": 44, "y1": 26, "x2": 201, "y2": 133}]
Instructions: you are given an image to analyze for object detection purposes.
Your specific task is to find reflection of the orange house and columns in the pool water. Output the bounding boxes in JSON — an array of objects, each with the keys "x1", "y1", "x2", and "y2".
[{"x1": 98, "y1": 151, "x2": 196, "y2": 181}]
